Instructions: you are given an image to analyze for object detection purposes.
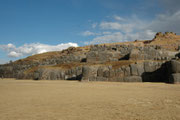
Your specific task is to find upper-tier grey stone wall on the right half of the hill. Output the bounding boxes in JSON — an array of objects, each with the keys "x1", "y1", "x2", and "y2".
[{"x1": 87, "y1": 45, "x2": 178, "y2": 63}]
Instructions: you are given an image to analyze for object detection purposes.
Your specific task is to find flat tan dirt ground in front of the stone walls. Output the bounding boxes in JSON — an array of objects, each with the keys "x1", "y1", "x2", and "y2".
[{"x1": 0, "y1": 79, "x2": 180, "y2": 120}]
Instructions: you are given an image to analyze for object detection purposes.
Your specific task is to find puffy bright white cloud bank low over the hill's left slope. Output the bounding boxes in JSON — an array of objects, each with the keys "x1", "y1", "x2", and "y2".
[{"x1": 0, "y1": 43, "x2": 78, "y2": 57}]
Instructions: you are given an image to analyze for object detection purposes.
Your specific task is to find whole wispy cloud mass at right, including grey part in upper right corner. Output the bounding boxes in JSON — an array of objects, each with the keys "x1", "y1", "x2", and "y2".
[{"x1": 82, "y1": 4, "x2": 180, "y2": 44}]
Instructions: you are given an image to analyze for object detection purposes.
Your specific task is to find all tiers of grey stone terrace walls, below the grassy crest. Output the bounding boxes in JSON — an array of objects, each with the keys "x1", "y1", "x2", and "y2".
[{"x1": 0, "y1": 45, "x2": 180, "y2": 83}]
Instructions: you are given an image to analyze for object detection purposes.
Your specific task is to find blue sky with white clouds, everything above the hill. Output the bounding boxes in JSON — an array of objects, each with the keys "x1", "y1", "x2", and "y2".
[{"x1": 0, "y1": 0, "x2": 180, "y2": 63}]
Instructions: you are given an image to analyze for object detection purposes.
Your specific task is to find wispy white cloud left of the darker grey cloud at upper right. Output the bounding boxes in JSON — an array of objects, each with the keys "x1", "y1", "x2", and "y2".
[{"x1": 85, "y1": 15, "x2": 156, "y2": 44}]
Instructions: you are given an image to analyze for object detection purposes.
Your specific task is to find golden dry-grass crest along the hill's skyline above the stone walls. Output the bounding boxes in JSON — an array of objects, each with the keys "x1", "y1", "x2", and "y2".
[{"x1": 11, "y1": 32, "x2": 180, "y2": 63}]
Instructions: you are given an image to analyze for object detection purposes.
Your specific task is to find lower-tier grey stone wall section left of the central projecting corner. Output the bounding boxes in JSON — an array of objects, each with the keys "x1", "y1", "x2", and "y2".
[{"x1": 17, "y1": 66, "x2": 82, "y2": 80}]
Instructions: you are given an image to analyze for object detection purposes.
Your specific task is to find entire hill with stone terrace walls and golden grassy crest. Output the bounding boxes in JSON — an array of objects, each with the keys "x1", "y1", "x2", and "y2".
[{"x1": 0, "y1": 32, "x2": 180, "y2": 83}]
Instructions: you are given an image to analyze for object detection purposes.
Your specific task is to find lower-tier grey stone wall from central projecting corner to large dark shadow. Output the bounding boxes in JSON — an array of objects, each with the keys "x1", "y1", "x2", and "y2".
[{"x1": 82, "y1": 61, "x2": 167, "y2": 82}]
